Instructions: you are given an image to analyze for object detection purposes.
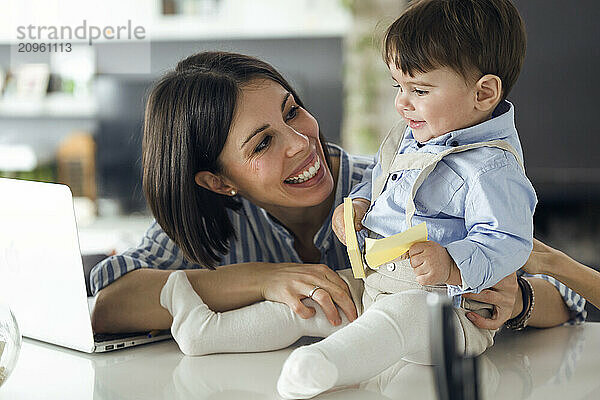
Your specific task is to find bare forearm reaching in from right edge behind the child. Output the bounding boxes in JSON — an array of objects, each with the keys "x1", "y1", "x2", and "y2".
[{"x1": 523, "y1": 239, "x2": 600, "y2": 307}]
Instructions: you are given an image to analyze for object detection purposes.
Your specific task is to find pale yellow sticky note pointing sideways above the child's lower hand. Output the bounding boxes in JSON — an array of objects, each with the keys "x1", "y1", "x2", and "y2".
[{"x1": 364, "y1": 222, "x2": 427, "y2": 267}]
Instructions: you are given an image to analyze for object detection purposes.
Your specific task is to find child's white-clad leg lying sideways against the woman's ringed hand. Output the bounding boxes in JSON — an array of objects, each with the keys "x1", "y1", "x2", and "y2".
[{"x1": 160, "y1": 271, "x2": 360, "y2": 355}]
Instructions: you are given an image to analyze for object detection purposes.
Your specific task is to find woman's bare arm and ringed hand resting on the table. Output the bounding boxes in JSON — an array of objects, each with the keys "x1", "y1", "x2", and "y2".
[{"x1": 92, "y1": 263, "x2": 356, "y2": 333}]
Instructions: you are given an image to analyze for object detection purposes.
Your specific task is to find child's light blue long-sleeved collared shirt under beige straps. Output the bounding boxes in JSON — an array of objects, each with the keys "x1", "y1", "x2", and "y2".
[{"x1": 351, "y1": 101, "x2": 537, "y2": 295}]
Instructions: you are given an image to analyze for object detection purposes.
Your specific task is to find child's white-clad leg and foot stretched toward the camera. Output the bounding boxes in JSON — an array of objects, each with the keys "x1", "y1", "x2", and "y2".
[{"x1": 277, "y1": 290, "x2": 440, "y2": 399}]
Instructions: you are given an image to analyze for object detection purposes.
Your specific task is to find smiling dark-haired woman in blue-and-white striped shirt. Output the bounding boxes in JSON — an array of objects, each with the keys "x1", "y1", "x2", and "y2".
[{"x1": 91, "y1": 52, "x2": 583, "y2": 340}]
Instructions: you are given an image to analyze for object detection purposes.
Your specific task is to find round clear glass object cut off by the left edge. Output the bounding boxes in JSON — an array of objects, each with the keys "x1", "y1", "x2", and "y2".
[{"x1": 0, "y1": 303, "x2": 21, "y2": 386}]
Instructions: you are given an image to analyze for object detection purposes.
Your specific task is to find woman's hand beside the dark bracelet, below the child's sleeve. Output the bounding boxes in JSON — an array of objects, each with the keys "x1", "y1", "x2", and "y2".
[{"x1": 463, "y1": 273, "x2": 523, "y2": 329}]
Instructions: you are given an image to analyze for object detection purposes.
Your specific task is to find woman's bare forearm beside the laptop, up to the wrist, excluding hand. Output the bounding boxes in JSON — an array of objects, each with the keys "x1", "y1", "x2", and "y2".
[{"x1": 92, "y1": 263, "x2": 263, "y2": 333}]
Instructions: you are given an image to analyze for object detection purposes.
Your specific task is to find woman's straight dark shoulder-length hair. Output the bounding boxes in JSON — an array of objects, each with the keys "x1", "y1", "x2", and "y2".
[{"x1": 142, "y1": 52, "x2": 329, "y2": 268}]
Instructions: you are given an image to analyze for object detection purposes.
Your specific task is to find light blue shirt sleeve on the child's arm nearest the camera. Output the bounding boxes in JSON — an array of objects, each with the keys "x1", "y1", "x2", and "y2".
[{"x1": 446, "y1": 156, "x2": 537, "y2": 294}]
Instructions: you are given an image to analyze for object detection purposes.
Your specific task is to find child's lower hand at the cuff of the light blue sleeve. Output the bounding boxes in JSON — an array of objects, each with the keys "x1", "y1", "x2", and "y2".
[{"x1": 408, "y1": 241, "x2": 460, "y2": 285}]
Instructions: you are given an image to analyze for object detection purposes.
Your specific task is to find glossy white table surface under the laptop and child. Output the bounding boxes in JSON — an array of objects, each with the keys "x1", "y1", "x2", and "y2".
[{"x1": 0, "y1": 323, "x2": 600, "y2": 400}]
